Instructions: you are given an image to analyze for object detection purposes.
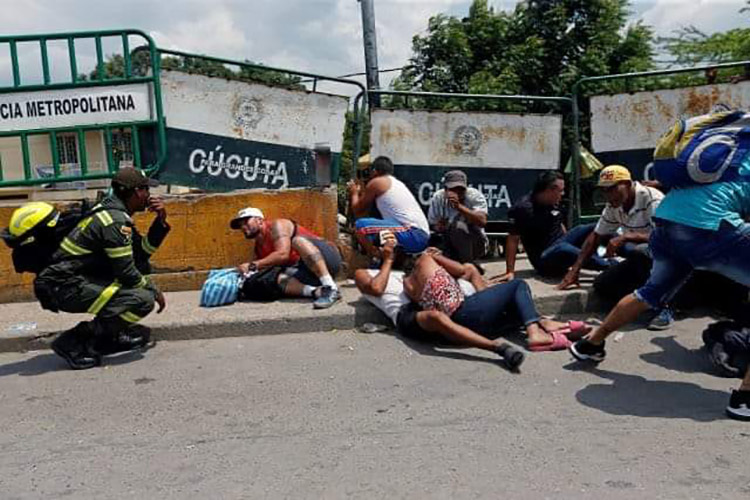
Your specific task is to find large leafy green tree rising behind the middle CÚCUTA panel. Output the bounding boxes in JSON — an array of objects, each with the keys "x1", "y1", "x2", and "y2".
[{"x1": 395, "y1": 0, "x2": 653, "y2": 101}]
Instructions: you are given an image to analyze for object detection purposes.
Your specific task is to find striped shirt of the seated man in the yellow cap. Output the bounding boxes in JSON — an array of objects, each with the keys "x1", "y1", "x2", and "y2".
[{"x1": 594, "y1": 182, "x2": 664, "y2": 236}]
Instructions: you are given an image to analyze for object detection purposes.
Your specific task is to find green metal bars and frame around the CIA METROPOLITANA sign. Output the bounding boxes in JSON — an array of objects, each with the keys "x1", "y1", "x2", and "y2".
[{"x1": 0, "y1": 30, "x2": 167, "y2": 187}]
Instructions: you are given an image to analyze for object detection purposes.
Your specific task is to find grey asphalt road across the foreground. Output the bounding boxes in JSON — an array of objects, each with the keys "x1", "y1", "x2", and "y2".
[{"x1": 0, "y1": 319, "x2": 750, "y2": 500}]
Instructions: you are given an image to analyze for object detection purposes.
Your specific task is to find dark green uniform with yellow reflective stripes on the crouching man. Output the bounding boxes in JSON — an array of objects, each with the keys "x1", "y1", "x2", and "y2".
[{"x1": 34, "y1": 196, "x2": 170, "y2": 335}]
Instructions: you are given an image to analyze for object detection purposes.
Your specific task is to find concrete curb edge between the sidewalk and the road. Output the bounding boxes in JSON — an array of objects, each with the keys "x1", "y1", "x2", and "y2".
[{"x1": 0, "y1": 291, "x2": 606, "y2": 353}]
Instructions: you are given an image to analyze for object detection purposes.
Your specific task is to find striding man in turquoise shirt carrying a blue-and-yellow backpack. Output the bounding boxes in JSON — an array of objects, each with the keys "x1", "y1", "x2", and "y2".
[{"x1": 570, "y1": 110, "x2": 750, "y2": 420}]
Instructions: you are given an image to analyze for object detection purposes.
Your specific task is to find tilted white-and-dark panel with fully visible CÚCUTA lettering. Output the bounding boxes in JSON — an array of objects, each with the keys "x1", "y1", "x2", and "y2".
[{"x1": 159, "y1": 71, "x2": 349, "y2": 190}]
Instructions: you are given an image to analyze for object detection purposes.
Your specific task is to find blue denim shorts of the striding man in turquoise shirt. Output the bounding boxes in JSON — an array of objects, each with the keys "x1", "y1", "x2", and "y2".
[{"x1": 635, "y1": 219, "x2": 750, "y2": 309}]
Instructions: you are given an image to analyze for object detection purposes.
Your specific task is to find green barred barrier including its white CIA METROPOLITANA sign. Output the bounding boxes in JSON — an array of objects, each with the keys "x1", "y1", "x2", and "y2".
[{"x1": 0, "y1": 30, "x2": 166, "y2": 187}]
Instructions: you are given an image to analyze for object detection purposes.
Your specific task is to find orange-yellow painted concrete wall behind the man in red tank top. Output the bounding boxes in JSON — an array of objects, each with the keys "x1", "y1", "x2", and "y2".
[{"x1": 0, "y1": 189, "x2": 338, "y2": 302}]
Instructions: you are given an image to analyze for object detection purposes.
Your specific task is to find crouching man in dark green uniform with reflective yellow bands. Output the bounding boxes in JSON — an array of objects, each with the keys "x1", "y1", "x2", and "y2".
[{"x1": 34, "y1": 168, "x2": 170, "y2": 370}]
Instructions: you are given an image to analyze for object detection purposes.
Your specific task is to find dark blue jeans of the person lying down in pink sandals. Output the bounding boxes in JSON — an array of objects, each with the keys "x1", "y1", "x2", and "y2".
[{"x1": 451, "y1": 280, "x2": 540, "y2": 334}]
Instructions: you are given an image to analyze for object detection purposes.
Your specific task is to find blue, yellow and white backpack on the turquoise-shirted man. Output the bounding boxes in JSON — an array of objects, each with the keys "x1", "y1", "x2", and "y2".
[{"x1": 652, "y1": 111, "x2": 750, "y2": 189}]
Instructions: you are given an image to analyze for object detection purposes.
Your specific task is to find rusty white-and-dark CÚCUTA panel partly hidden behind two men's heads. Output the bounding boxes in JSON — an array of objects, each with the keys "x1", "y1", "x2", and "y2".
[{"x1": 370, "y1": 109, "x2": 562, "y2": 221}]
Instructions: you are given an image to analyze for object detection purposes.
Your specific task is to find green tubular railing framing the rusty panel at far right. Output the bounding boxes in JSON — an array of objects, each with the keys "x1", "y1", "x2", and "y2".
[{"x1": 571, "y1": 61, "x2": 750, "y2": 224}]
